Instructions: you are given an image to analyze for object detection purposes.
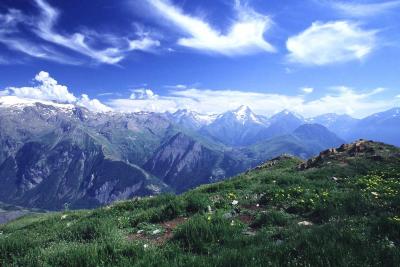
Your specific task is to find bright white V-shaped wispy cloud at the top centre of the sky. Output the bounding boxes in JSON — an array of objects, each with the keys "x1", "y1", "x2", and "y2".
[{"x1": 147, "y1": 0, "x2": 275, "y2": 56}]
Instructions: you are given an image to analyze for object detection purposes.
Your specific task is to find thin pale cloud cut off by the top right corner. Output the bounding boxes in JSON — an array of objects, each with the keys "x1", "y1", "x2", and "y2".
[{"x1": 330, "y1": 0, "x2": 400, "y2": 17}]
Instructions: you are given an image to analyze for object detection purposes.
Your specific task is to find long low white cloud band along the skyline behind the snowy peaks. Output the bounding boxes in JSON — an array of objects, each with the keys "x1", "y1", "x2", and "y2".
[{"x1": 107, "y1": 87, "x2": 398, "y2": 117}]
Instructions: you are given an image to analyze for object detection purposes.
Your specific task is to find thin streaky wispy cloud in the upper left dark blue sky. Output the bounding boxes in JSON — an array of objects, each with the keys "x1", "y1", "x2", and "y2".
[{"x1": 0, "y1": 0, "x2": 160, "y2": 64}]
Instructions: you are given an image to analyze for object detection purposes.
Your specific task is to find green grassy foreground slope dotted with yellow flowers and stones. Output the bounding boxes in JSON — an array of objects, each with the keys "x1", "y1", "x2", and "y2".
[{"x1": 0, "y1": 143, "x2": 400, "y2": 266}]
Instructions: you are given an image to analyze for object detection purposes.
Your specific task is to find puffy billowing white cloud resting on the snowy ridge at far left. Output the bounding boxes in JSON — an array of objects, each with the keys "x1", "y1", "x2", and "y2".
[{"x1": 0, "y1": 71, "x2": 112, "y2": 112}]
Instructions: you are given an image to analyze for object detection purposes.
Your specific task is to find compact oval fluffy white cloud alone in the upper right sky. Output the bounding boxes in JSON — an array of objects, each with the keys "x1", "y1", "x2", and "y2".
[{"x1": 286, "y1": 21, "x2": 377, "y2": 65}]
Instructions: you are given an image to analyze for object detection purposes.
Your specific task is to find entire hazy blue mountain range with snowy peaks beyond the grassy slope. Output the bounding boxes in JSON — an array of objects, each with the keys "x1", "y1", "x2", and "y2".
[{"x1": 0, "y1": 97, "x2": 400, "y2": 210}]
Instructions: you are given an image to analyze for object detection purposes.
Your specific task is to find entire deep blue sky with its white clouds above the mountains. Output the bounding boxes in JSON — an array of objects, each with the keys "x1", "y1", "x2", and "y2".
[{"x1": 0, "y1": 0, "x2": 400, "y2": 117}]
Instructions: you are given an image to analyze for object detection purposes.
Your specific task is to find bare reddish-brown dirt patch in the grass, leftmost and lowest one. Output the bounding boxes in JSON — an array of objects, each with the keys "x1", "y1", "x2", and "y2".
[{"x1": 128, "y1": 217, "x2": 187, "y2": 245}]
